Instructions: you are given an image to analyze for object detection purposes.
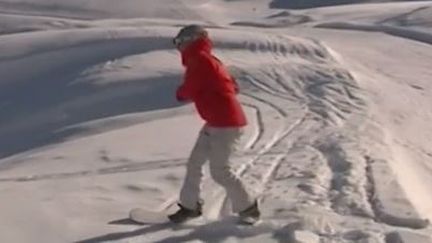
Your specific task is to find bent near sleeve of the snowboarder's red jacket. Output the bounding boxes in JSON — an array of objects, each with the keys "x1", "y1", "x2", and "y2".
[{"x1": 176, "y1": 53, "x2": 212, "y2": 101}]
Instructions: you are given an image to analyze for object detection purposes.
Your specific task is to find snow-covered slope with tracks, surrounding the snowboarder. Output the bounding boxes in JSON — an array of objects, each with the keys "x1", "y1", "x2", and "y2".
[{"x1": 0, "y1": 0, "x2": 432, "y2": 243}]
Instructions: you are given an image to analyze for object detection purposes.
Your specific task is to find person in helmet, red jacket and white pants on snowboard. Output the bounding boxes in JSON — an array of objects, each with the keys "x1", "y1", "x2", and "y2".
[{"x1": 168, "y1": 25, "x2": 260, "y2": 223}]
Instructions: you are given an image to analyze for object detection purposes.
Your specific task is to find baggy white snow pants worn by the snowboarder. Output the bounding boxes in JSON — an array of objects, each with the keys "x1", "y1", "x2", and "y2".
[{"x1": 180, "y1": 125, "x2": 254, "y2": 213}]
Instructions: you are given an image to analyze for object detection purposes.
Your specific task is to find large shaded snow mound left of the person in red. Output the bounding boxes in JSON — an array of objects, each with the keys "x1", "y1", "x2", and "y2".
[{"x1": 0, "y1": 28, "x2": 180, "y2": 159}]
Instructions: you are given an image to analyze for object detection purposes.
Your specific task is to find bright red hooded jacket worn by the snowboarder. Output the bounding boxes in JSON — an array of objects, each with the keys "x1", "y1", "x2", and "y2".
[{"x1": 177, "y1": 38, "x2": 247, "y2": 127}]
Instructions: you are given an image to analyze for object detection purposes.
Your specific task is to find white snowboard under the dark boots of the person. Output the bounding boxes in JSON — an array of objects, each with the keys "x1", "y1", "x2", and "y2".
[{"x1": 129, "y1": 208, "x2": 261, "y2": 226}]
